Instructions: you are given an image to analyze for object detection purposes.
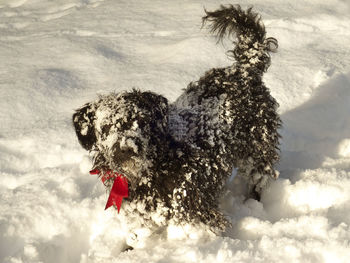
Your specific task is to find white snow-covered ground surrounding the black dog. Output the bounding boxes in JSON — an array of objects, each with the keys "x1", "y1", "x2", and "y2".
[{"x1": 0, "y1": 0, "x2": 350, "y2": 263}]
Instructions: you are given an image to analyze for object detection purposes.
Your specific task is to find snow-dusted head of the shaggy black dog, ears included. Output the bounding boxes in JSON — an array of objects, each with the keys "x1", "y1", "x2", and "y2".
[{"x1": 73, "y1": 90, "x2": 168, "y2": 184}]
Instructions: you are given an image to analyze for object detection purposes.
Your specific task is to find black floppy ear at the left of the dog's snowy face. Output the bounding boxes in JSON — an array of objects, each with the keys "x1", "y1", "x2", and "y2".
[{"x1": 73, "y1": 103, "x2": 97, "y2": 151}]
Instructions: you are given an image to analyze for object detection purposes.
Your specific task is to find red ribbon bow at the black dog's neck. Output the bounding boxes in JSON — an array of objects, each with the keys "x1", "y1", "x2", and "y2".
[{"x1": 90, "y1": 169, "x2": 129, "y2": 213}]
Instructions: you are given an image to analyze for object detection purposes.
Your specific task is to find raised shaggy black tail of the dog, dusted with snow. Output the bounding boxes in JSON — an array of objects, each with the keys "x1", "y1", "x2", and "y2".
[{"x1": 202, "y1": 5, "x2": 278, "y2": 72}]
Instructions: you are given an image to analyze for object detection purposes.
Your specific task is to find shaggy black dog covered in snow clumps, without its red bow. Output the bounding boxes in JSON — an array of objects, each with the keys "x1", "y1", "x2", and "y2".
[{"x1": 73, "y1": 6, "x2": 281, "y2": 233}]
